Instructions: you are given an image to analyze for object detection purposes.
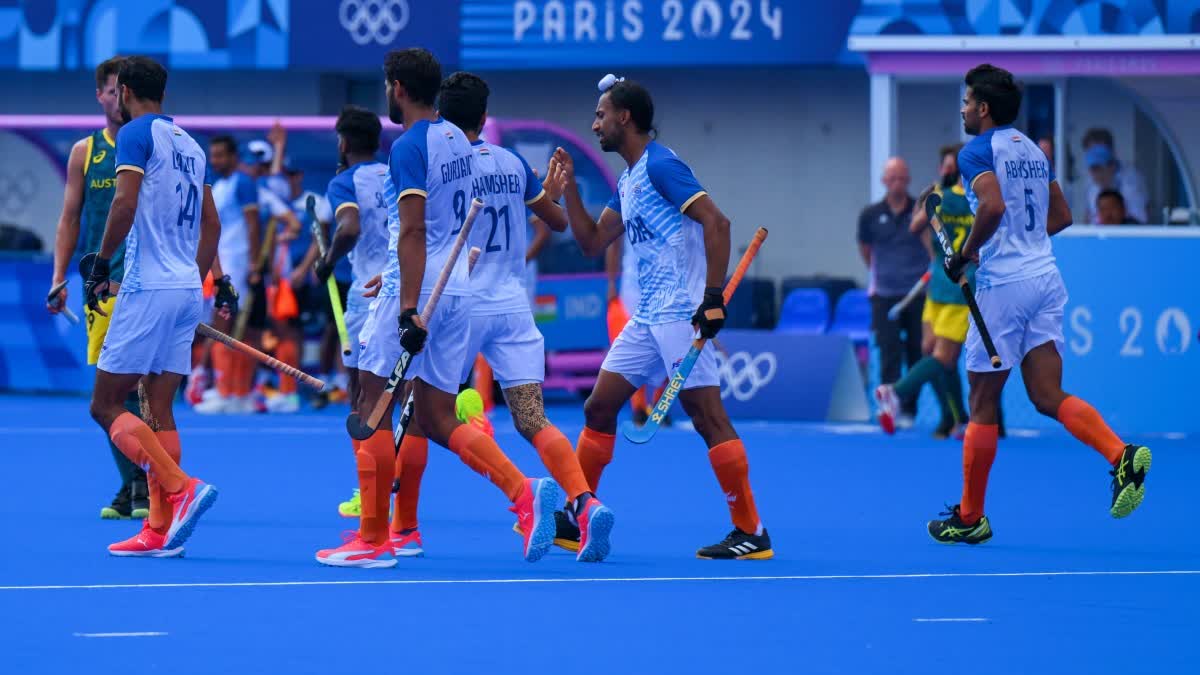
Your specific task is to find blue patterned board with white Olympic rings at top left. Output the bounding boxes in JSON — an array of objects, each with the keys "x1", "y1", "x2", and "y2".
[{"x1": 0, "y1": 0, "x2": 458, "y2": 71}]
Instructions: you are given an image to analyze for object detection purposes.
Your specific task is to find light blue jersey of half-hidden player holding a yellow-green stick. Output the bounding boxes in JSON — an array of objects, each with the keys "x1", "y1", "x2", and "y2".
[{"x1": 328, "y1": 162, "x2": 388, "y2": 304}]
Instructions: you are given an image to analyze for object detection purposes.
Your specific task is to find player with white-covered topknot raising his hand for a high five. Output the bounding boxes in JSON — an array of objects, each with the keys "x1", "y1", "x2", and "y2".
[{"x1": 550, "y1": 74, "x2": 774, "y2": 560}]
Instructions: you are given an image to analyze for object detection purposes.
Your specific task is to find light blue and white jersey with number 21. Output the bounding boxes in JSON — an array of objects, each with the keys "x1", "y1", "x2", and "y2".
[{"x1": 469, "y1": 141, "x2": 545, "y2": 316}]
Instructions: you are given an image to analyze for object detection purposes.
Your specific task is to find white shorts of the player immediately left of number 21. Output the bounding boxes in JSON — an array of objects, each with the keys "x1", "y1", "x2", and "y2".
[{"x1": 359, "y1": 294, "x2": 470, "y2": 394}]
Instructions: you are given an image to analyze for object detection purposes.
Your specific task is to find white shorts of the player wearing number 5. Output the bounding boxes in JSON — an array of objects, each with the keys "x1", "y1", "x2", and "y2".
[{"x1": 966, "y1": 269, "x2": 1067, "y2": 372}]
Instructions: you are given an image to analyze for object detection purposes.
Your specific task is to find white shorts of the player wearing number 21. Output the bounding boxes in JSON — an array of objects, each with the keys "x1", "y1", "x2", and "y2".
[{"x1": 462, "y1": 311, "x2": 546, "y2": 389}]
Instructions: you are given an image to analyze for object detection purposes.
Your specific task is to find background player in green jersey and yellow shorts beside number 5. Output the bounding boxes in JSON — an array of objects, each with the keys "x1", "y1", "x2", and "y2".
[{"x1": 875, "y1": 145, "x2": 974, "y2": 438}]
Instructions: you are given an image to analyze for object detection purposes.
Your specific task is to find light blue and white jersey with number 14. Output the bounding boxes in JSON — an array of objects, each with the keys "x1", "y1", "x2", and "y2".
[{"x1": 116, "y1": 114, "x2": 208, "y2": 293}]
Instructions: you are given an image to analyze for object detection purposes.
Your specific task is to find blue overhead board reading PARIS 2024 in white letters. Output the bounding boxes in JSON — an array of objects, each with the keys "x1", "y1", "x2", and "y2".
[{"x1": 461, "y1": 0, "x2": 857, "y2": 68}]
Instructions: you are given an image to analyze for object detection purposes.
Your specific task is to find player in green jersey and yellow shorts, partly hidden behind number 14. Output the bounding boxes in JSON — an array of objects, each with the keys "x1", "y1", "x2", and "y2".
[{"x1": 47, "y1": 56, "x2": 150, "y2": 519}]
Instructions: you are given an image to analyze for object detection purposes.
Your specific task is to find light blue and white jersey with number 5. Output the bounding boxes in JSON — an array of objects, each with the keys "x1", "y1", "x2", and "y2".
[{"x1": 959, "y1": 126, "x2": 1055, "y2": 288}]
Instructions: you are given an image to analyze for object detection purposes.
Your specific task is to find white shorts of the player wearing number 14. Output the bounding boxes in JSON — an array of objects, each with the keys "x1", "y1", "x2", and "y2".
[{"x1": 96, "y1": 288, "x2": 204, "y2": 375}]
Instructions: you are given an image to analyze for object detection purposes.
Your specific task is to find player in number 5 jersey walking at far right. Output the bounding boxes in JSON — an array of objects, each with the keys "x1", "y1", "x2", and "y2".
[{"x1": 928, "y1": 64, "x2": 1151, "y2": 544}]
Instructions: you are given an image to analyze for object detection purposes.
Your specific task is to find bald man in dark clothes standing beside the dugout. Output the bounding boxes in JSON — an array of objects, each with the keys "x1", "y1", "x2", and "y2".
[{"x1": 858, "y1": 157, "x2": 929, "y2": 428}]
